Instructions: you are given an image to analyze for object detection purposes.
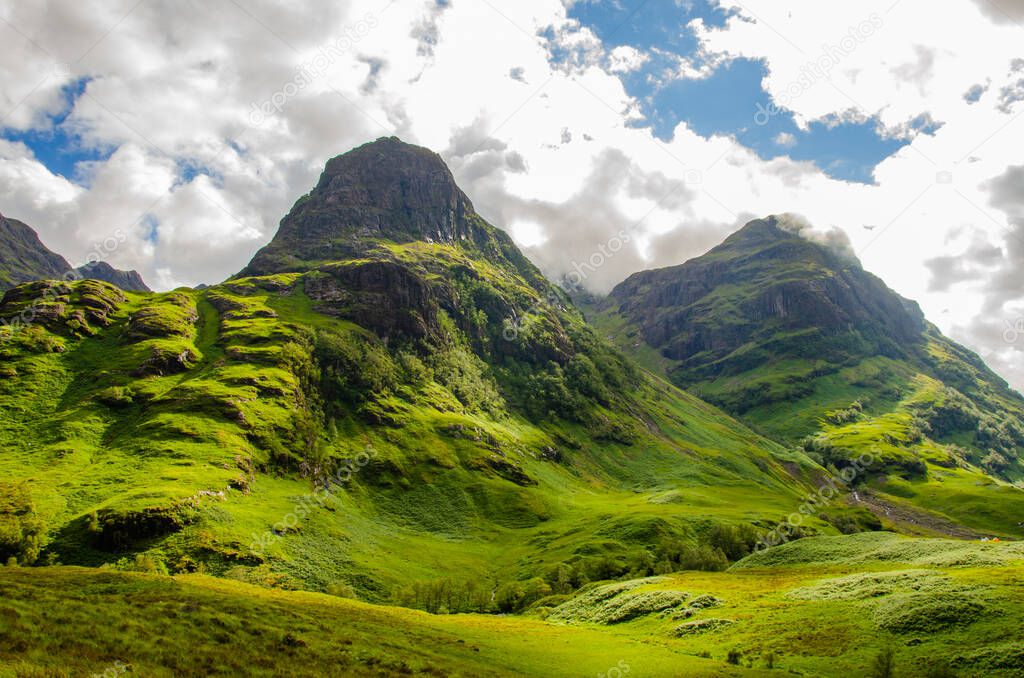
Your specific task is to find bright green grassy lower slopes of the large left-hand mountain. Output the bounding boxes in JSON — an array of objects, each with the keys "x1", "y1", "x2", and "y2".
[{"x1": 0, "y1": 264, "x2": 819, "y2": 606}]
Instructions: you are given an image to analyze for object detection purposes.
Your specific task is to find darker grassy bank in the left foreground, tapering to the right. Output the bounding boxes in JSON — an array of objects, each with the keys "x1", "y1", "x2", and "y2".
[{"x1": 0, "y1": 567, "x2": 742, "y2": 678}]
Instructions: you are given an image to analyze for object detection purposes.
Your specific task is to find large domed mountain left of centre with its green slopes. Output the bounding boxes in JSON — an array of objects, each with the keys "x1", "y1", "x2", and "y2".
[{"x1": 0, "y1": 139, "x2": 819, "y2": 610}]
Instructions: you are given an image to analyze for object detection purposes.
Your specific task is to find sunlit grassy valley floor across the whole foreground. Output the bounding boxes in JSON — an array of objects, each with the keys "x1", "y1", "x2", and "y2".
[{"x1": 0, "y1": 533, "x2": 1024, "y2": 678}]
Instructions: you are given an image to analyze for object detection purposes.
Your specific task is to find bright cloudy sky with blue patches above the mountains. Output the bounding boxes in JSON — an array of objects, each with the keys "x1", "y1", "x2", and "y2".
[{"x1": 0, "y1": 0, "x2": 1024, "y2": 389}]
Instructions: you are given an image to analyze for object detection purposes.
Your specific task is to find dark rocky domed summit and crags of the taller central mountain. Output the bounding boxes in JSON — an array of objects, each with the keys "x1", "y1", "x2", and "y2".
[{"x1": 237, "y1": 137, "x2": 578, "y2": 365}]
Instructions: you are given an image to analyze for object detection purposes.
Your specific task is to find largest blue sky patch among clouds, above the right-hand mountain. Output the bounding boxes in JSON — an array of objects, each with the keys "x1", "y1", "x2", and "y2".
[{"x1": 553, "y1": 0, "x2": 938, "y2": 183}]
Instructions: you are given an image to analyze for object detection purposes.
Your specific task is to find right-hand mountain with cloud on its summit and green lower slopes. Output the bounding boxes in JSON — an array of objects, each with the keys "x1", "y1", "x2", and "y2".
[{"x1": 592, "y1": 217, "x2": 1024, "y2": 536}]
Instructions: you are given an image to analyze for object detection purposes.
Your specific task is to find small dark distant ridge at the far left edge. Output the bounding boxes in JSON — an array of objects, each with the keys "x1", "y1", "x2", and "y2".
[{"x1": 0, "y1": 214, "x2": 150, "y2": 292}]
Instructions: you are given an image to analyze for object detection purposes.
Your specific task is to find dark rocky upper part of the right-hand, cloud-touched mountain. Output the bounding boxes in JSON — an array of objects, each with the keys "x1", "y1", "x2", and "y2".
[{"x1": 609, "y1": 217, "x2": 925, "y2": 377}]
